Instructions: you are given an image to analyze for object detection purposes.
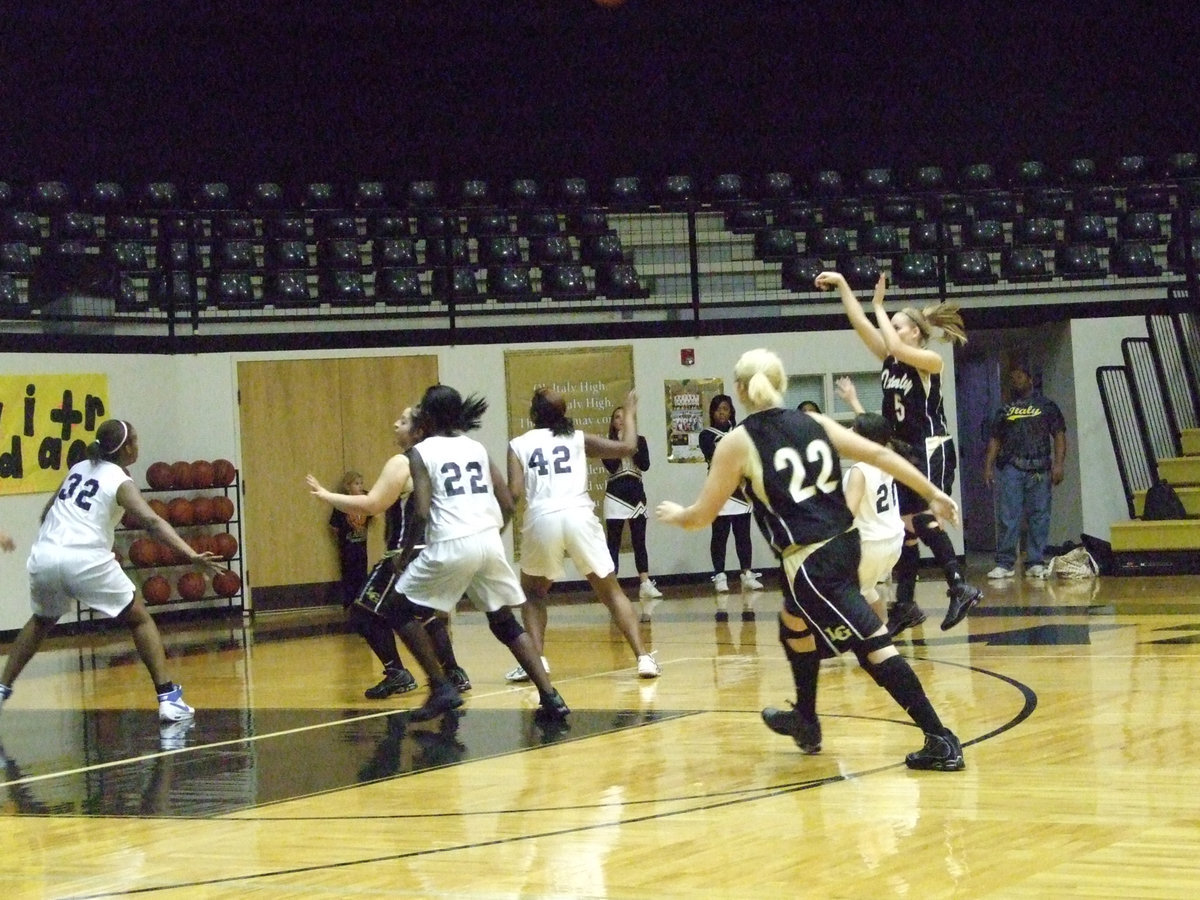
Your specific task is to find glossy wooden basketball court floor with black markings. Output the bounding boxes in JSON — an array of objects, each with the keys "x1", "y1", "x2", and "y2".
[{"x1": 0, "y1": 564, "x2": 1200, "y2": 898}]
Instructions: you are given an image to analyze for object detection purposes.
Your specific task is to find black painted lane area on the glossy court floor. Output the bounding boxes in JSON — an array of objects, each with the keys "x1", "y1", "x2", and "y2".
[{"x1": 0, "y1": 709, "x2": 690, "y2": 817}]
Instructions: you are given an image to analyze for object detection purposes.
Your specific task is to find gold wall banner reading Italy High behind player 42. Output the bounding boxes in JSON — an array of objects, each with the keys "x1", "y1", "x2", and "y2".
[{"x1": 497, "y1": 344, "x2": 638, "y2": 554}]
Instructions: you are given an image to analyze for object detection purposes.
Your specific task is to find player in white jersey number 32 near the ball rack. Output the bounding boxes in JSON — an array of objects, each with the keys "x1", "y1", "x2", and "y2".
[{"x1": 0, "y1": 419, "x2": 221, "y2": 724}]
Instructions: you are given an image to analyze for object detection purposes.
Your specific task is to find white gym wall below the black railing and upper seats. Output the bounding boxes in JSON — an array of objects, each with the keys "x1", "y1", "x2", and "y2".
[{"x1": 0, "y1": 318, "x2": 1145, "y2": 631}]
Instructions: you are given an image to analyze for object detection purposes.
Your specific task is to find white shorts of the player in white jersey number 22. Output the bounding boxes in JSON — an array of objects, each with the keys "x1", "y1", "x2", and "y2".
[{"x1": 396, "y1": 528, "x2": 524, "y2": 612}]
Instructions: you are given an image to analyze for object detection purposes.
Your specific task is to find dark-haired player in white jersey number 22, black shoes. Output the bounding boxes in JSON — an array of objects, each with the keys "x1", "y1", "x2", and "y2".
[{"x1": 386, "y1": 384, "x2": 570, "y2": 720}]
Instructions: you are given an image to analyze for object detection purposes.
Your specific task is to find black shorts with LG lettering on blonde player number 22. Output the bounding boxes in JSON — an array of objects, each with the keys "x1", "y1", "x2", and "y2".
[{"x1": 782, "y1": 528, "x2": 883, "y2": 659}]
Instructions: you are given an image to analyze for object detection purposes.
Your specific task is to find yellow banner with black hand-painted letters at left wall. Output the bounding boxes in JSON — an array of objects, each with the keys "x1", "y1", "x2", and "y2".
[{"x1": 0, "y1": 374, "x2": 109, "y2": 496}]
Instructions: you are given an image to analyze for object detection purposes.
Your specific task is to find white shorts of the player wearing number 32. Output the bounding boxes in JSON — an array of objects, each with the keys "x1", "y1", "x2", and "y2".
[{"x1": 25, "y1": 545, "x2": 133, "y2": 619}]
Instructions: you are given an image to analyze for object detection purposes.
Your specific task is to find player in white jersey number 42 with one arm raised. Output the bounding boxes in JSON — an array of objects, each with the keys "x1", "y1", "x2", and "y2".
[{"x1": 505, "y1": 388, "x2": 661, "y2": 682}]
